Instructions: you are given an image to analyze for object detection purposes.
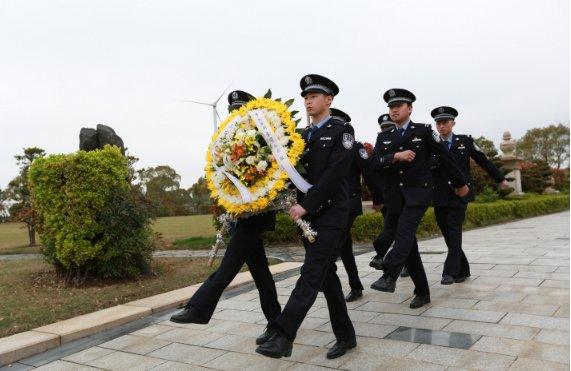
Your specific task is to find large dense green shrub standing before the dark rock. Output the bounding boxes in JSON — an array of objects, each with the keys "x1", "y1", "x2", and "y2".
[{"x1": 29, "y1": 146, "x2": 153, "y2": 284}]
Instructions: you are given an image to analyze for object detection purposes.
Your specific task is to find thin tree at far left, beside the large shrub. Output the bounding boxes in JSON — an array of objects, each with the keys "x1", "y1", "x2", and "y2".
[{"x1": 3, "y1": 147, "x2": 46, "y2": 246}]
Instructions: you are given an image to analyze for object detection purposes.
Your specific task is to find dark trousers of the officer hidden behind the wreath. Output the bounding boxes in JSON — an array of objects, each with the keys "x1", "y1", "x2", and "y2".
[{"x1": 187, "y1": 225, "x2": 281, "y2": 324}]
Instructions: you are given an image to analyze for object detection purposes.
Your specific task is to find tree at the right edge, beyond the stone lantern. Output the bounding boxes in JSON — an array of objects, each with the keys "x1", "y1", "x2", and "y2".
[{"x1": 516, "y1": 124, "x2": 569, "y2": 169}]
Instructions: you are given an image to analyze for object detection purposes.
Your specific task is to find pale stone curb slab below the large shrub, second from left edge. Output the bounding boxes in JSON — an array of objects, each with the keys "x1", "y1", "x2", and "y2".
[{"x1": 36, "y1": 305, "x2": 151, "y2": 344}]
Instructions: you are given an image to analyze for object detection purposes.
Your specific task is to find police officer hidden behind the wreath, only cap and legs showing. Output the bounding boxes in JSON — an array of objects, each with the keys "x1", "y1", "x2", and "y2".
[{"x1": 170, "y1": 90, "x2": 281, "y2": 344}]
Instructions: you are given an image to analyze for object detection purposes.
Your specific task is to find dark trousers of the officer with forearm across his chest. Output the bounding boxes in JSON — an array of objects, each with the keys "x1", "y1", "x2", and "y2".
[{"x1": 383, "y1": 204, "x2": 430, "y2": 295}]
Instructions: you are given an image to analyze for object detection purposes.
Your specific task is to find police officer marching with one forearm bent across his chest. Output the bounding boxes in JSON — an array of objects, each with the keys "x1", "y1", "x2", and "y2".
[{"x1": 371, "y1": 89, "x2": 468, "y2": 308}]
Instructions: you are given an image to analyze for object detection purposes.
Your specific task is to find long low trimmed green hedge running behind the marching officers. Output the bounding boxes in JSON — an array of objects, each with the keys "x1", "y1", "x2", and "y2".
[{"x1": 264, "y1": 194, "x2": 569, "y2": 244}]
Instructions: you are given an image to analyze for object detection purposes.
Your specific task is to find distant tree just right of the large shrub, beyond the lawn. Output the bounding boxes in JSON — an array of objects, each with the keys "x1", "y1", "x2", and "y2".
[{"x1": 137, "y1": 165, "x2": 191, "y2": 216}]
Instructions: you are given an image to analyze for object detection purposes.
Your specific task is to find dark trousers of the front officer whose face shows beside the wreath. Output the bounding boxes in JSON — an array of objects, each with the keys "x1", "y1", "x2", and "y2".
[{"x1": 274, "y1": 226, "x2": 355, "y2": 341}]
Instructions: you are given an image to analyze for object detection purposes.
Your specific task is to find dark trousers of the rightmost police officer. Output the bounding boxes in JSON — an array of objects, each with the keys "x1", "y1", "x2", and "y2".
[{"x1": 434, "y1": 198, "x2": 470, "y2": 278}]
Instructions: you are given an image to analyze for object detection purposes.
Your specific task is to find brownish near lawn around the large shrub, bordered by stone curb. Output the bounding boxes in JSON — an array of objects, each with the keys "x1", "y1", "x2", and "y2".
[{"x1": 0, "y1": 258, "x2": 280, "y2": 337}]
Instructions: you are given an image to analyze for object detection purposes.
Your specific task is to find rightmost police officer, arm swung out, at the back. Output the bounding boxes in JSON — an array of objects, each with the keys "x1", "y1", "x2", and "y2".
[{"x1": 430, "y1": 106, "x2": 508, "y2": 285}]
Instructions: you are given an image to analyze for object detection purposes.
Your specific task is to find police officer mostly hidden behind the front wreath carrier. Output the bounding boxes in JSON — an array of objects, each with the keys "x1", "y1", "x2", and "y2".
[{"x1": 330, "y1": 108, "x2": 383, "y2": 302}]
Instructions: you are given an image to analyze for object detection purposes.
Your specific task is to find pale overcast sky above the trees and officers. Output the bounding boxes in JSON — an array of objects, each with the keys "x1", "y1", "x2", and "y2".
[{"x1": 0, "y1": 0, "x2": 569, "y2": 188}]
